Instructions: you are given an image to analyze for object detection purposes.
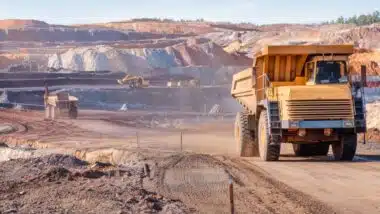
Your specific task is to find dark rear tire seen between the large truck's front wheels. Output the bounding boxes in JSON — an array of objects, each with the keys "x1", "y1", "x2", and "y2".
[{"x1": 293, "y1": 143, "x2": 330, "y2": 157}]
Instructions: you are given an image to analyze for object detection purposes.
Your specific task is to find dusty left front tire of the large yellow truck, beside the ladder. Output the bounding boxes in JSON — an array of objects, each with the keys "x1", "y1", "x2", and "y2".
[{"x1": 258, "y1": 110, "x2": 281, "y2": 161}]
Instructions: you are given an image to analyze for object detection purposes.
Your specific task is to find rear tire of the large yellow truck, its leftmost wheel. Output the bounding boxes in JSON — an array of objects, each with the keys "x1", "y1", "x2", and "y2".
[{"x1": 235, "y1": 112, "x2": 258, "y2": 157}]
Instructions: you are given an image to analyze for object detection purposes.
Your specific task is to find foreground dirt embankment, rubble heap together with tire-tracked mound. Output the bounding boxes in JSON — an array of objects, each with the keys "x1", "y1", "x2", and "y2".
[{"x1": 0, "y1": 149, "x2": 333, "y2": 213}]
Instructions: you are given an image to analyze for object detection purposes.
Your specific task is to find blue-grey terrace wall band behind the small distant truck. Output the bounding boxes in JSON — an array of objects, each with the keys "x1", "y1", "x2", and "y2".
[{"x1": 0, "y1": 87, "x2": 240, "y2": 113}]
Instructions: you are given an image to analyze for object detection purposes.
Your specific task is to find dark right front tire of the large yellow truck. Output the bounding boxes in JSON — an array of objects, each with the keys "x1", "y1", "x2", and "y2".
[{"x1": 331, "y1": 133, "x2": 358, "y2": 161}]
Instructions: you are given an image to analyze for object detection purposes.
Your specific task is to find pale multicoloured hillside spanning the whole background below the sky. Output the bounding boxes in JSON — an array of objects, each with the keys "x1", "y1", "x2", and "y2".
[{"x1": 0, "y1": 19, "x2": 380, "y2": 74}]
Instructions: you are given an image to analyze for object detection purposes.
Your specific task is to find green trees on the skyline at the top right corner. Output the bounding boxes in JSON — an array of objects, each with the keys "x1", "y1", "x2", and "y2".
[{"x1": 323, "y1": 11, "x2": 380, "y2": 25}]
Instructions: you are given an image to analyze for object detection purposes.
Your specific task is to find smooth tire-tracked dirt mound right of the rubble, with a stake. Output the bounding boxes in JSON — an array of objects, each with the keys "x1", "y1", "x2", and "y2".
[{"x1": 156, "y1": 154, "x2": 334, "y2": 213}]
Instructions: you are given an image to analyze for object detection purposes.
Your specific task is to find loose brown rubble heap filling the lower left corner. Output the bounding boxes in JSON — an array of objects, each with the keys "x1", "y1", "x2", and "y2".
[{"x1": 0, "y1": 155, "x2": 190, "y2": 213}]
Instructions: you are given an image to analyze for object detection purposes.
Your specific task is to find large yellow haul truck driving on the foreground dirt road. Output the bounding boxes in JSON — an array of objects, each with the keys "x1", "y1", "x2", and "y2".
[{"x1": 231, "y1": 45, "x2": 366, "y2": 161}]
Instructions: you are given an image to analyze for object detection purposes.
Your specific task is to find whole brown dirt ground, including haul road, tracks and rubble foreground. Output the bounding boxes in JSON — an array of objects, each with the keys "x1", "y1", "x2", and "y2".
[{"x1": 0, "y1": 111, "x2": 380, "y2": 213}]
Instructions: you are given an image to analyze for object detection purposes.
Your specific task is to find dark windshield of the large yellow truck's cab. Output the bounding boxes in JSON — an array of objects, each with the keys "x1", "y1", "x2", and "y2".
[{"x1": 315, "y1": 61, "x2": 348, "y2": 84}]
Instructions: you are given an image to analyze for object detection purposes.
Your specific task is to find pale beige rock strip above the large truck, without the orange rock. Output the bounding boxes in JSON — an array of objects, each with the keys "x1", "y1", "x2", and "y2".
[{"x1": 209, "y1": 24, "x2": 380, "y2": 56}]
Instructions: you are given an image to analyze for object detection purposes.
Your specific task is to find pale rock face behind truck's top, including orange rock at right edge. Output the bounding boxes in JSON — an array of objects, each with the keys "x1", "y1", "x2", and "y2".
[{"x1": 205, "y1": 24, "x2": 380, "y2": 75}]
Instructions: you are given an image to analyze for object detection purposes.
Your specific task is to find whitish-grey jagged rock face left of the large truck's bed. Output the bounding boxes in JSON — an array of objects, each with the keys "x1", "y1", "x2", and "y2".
[{"x1": 48, "y1": 42, "x2": 251, "y2": 74}]
